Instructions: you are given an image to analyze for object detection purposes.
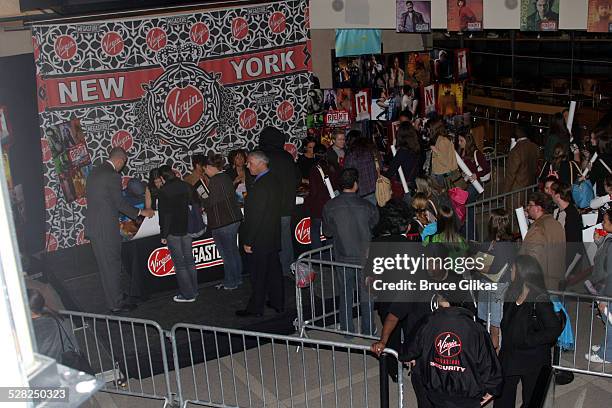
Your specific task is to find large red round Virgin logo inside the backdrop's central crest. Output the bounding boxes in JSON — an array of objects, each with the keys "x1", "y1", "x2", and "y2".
[{"x1": 165, "y1": 85, "x2": 204, "y2": 128}]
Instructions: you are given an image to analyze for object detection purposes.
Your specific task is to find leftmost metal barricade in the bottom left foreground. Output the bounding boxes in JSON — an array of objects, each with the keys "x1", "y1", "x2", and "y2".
[{"x1": 60, "y1": 311, "x2": 174, "y2": 407}]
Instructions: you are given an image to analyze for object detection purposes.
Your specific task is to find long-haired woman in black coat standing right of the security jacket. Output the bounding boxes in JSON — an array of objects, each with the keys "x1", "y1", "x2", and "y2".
[{"x1": 495, "y1": 255, "x2": 563, "y2": 408}]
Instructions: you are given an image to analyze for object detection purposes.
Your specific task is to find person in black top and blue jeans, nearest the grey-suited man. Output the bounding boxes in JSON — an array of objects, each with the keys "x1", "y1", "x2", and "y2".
[{"x1": 158, "y1": 165, "x2": 198, "y2": 303}]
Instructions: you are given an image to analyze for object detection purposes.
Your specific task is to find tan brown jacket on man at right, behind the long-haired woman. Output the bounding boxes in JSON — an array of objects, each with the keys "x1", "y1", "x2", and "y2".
[{"x1": 520, "y1": 214, "x2": 566, "y2": 290}]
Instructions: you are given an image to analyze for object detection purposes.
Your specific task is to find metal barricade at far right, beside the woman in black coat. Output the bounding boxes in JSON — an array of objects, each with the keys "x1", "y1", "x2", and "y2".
[{"x1": 550, "y1": 291, "x2": 612, "y2": 378}]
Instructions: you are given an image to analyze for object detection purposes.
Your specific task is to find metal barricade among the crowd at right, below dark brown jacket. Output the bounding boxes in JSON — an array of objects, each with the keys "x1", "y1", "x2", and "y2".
[{"x1": 465, "y1": 184, "x2": 538, "y2": 241}]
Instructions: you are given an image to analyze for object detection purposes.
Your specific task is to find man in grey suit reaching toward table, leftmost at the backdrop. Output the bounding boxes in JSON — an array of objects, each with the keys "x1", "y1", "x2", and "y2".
[{"x1": 85, "y1": 147, "x2": 155, "y2": 313}]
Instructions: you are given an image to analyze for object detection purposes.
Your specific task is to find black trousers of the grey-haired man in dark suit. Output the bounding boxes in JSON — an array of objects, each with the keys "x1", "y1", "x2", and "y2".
[{"x1": 247, "y1": 251, "x2": 285, "y2": 313}]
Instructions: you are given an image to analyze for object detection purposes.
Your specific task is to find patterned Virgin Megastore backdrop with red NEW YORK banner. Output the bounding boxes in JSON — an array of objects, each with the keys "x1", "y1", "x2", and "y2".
[{"x1": 32, "y1": 0, "x2": 311, "y2": 251}]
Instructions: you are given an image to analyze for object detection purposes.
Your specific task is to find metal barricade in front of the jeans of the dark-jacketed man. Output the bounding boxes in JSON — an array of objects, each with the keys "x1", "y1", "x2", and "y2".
[{"x1": 293, "y1": 245, "x2": 378, "y2": 340}]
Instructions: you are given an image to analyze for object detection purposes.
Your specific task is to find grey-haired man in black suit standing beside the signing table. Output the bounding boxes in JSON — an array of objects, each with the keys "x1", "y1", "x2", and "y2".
[{"x1": 236, "y1": 151, "x2": 285, "y2": 317}]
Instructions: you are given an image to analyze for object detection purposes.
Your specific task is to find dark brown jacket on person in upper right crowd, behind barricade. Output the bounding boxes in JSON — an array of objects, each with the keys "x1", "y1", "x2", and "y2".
[{"x1": 504, "y1": 139, "x2": 540, "y2": 193}]
